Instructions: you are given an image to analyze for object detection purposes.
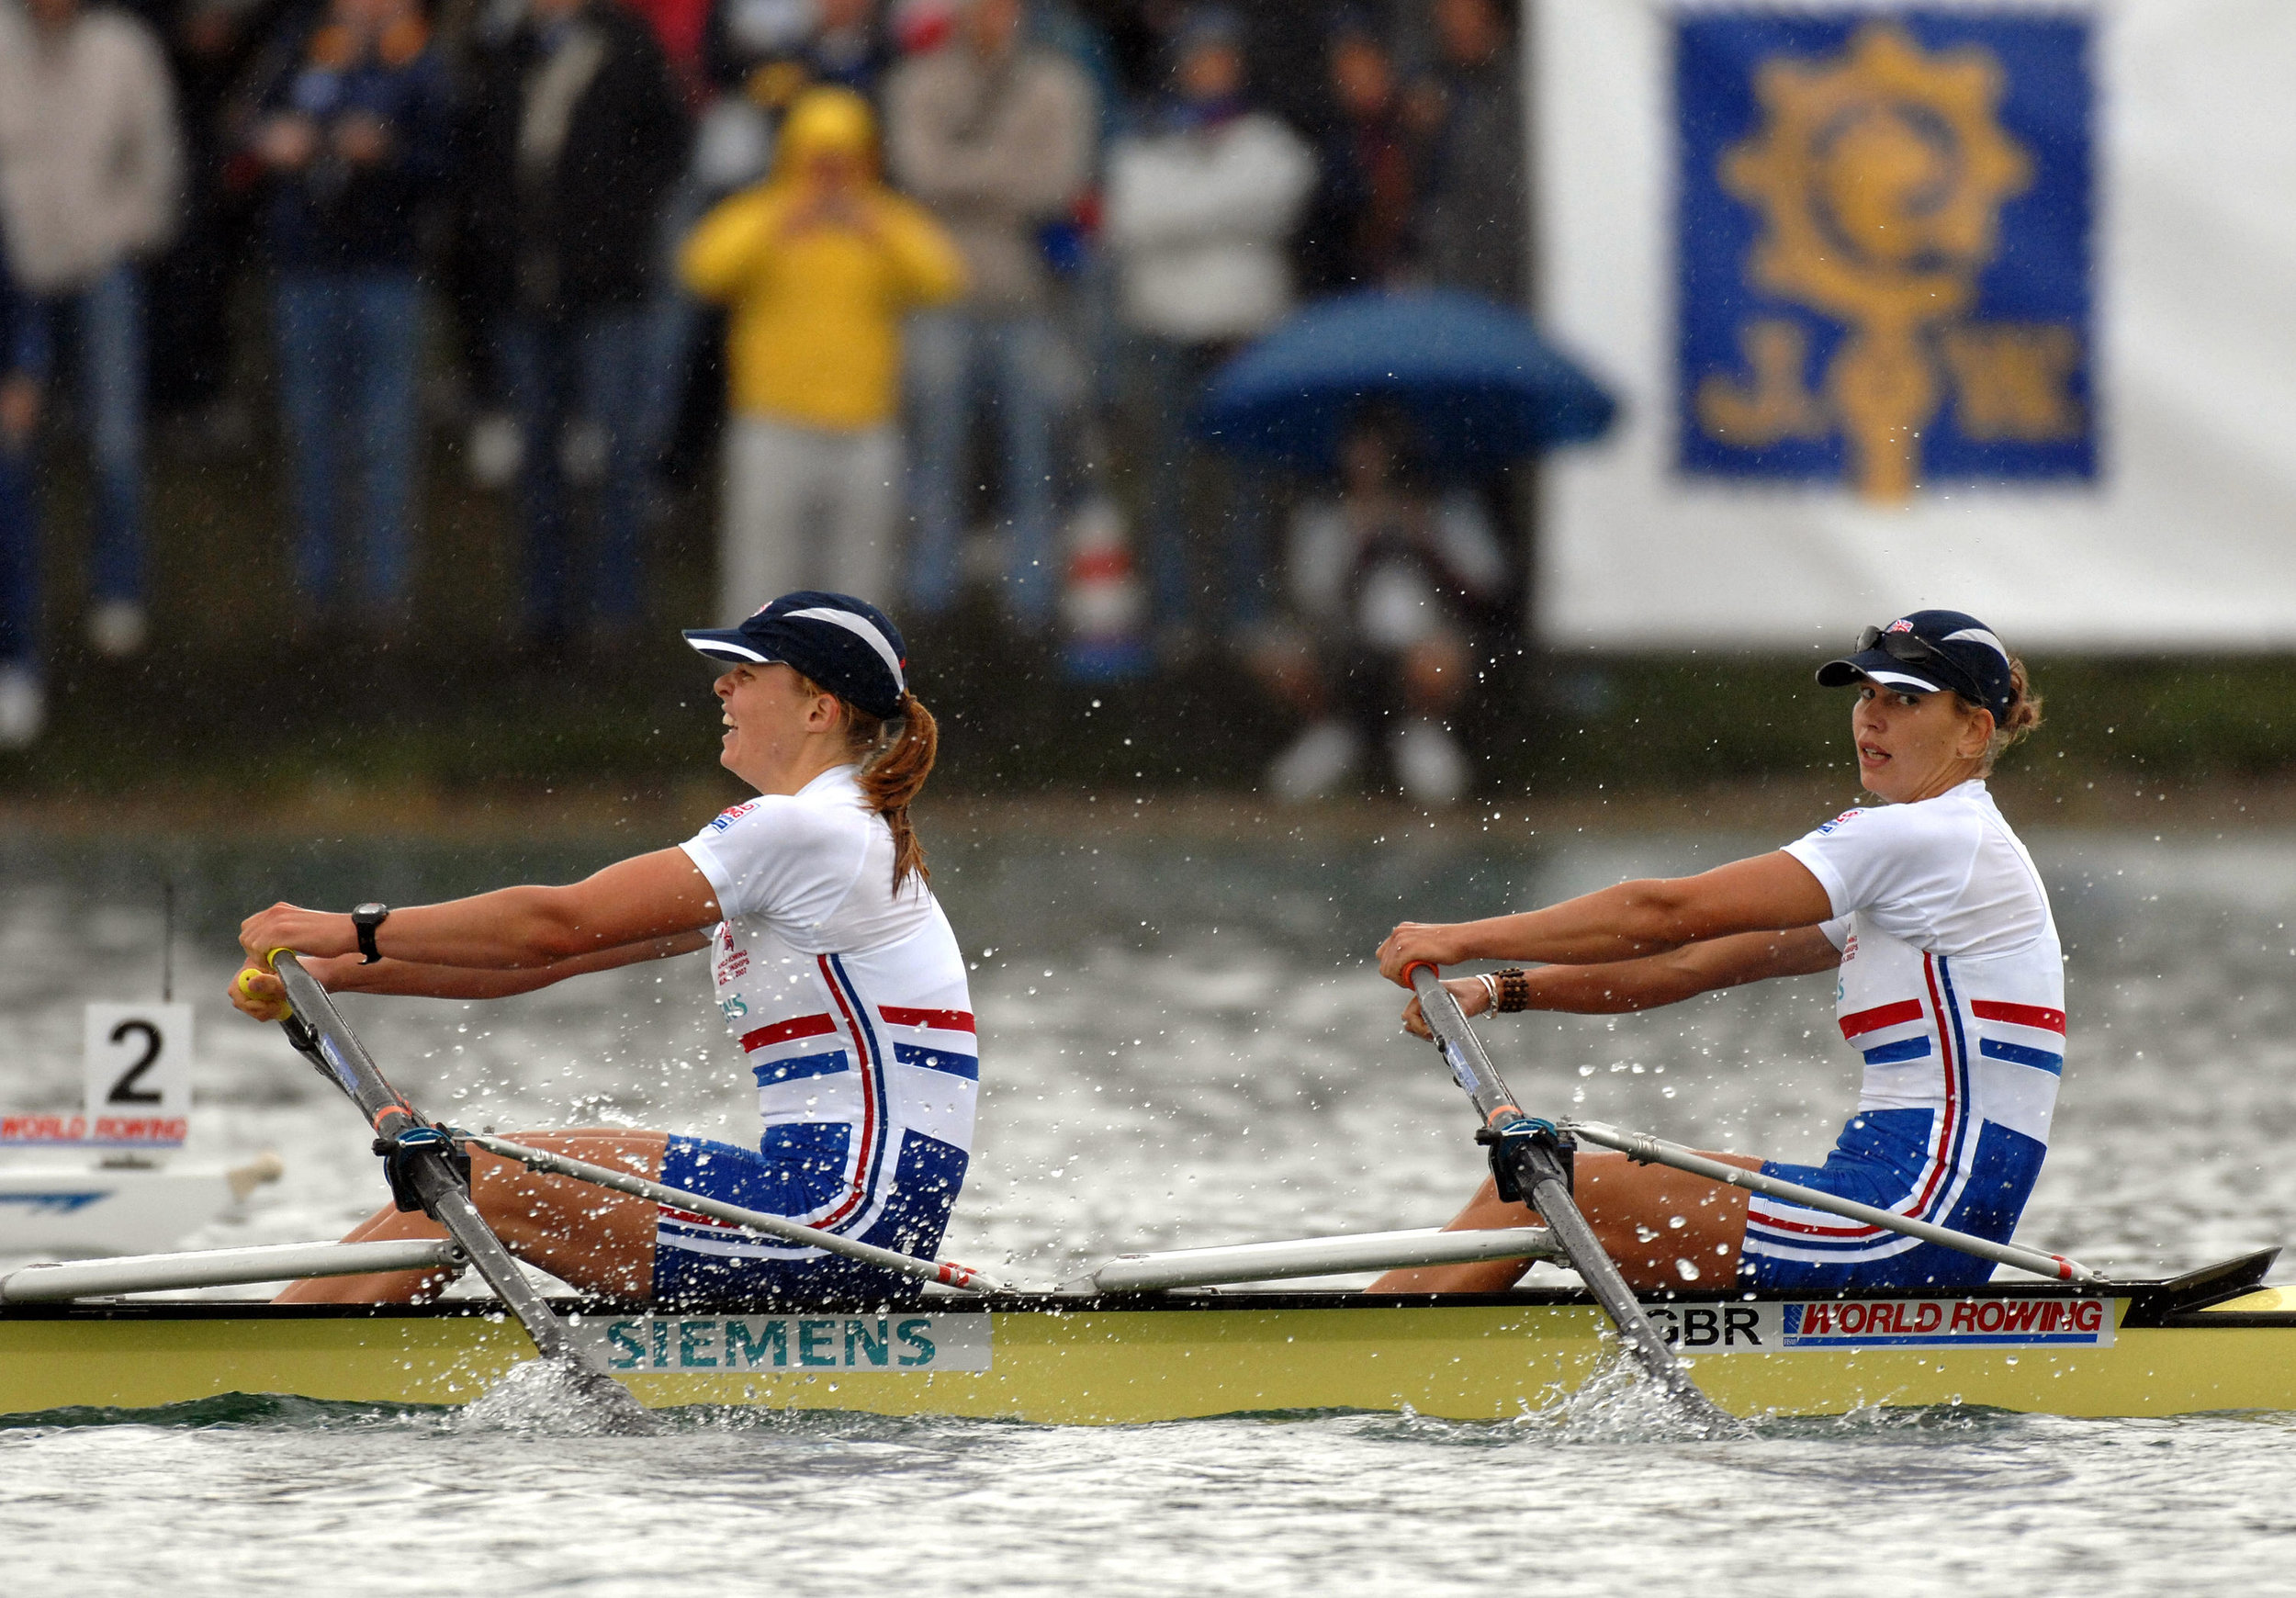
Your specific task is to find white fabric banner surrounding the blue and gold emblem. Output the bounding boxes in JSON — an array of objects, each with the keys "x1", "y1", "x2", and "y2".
[{"x1": 1527, "y1": 0, "x2": 2296, "y2": 652}]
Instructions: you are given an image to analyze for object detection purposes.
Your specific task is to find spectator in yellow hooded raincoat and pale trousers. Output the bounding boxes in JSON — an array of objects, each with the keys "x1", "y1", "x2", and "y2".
[{"x1": 680, "y1": 87, "x2": 964, "y2": 625}]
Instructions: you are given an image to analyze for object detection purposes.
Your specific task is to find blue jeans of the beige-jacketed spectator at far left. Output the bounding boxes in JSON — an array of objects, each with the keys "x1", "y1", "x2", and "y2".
[{"x1": 37, "y1": 262, "x2": 145, "y2": 604}]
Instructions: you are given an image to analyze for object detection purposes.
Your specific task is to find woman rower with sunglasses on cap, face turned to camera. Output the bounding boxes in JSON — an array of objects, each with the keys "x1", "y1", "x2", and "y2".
[{"x1": 1376, "y1": 611, "x2": 2065, "y2": 1293}]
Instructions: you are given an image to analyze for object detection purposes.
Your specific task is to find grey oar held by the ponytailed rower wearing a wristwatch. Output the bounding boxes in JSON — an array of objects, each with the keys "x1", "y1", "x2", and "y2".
[{"x1": 271, "y1": 949, "x2": 657, "y2": 1435}]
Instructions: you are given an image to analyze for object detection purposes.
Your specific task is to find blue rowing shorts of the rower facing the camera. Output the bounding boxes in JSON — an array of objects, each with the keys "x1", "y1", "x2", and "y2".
[{"x1": 1739, "y1": 1109, "x2": 2048, "y2": 1293}]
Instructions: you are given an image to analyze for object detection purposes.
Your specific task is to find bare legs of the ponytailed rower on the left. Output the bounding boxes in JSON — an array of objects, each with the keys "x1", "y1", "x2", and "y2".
[{"x1": 274, "y1": 1128, "x2": 670, "y2": 1304}]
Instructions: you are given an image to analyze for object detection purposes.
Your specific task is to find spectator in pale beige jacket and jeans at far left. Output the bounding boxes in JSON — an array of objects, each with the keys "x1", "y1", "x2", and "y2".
[{"x1": 0, "y1": 0, "x2": 184, "y2": 693}]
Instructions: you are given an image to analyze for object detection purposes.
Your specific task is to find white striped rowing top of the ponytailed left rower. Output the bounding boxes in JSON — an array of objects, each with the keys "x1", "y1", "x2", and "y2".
[{"x1": 682, "y1": 767, "x2": 981, "y2": 1238}]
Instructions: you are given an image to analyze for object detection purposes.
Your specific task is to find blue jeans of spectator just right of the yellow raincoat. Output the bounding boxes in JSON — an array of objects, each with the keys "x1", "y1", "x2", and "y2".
[{"x1": 907, "y1": 310, "x2": 1061, "y2": 629}]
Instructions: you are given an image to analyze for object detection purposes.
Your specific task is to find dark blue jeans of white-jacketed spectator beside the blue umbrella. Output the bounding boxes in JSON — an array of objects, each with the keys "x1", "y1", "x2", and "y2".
[{"x1": 1132, "y1": 335, "x2": 1270, "y2": 632}]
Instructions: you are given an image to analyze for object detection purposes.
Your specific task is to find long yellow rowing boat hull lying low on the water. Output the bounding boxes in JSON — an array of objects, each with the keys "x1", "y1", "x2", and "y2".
[{"x1": 0, "y1": 1289, "x2": 2296, "y2": 1426}]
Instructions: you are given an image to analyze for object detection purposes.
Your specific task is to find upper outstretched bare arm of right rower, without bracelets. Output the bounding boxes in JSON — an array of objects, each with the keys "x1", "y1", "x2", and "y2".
[{"x1": 1380, "y1": 850, "x2": 1835, "y2": 987}]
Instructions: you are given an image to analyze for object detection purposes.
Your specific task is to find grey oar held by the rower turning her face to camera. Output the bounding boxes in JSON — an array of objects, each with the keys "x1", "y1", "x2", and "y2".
[{"x1": 1403, "y1": 960, "x2": 1736, "y2": 1431}]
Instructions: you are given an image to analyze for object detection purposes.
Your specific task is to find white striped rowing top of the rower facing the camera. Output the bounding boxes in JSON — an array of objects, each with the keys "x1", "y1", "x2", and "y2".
[{"x1": 1748, "y1": 781, "x2": 2065, "y2": 1263}]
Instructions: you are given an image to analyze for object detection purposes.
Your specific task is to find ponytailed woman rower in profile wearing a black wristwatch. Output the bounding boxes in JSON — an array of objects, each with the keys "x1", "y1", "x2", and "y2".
[{"x1": 216, "y1": 592, "x2": 981, "y2": 1304}]
